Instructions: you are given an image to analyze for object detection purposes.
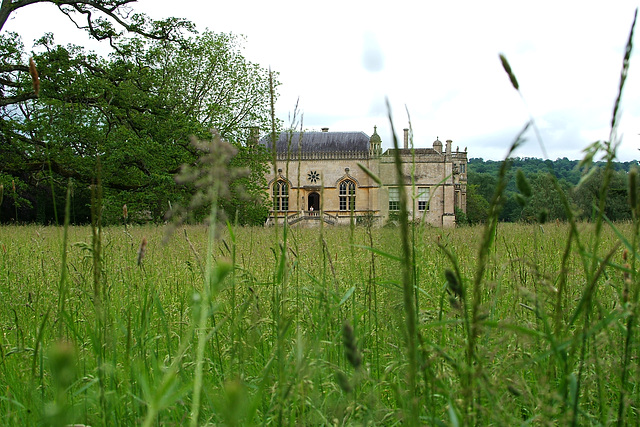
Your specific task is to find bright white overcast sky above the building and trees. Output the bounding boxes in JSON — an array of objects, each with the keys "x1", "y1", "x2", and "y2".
[{"x1": 4, "y1": 0, "x2": 640, "y2": 161}]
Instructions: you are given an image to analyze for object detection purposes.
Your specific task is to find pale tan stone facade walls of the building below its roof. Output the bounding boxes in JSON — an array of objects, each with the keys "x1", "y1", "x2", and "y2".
[{"x1": 267, "y1": 141, "x2": 467, "y2": 227}]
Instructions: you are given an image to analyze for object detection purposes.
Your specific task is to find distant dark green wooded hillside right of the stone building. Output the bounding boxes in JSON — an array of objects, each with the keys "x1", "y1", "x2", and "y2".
[{"x1": 462, "y1": 157, "x2": 638, "y2": 224}]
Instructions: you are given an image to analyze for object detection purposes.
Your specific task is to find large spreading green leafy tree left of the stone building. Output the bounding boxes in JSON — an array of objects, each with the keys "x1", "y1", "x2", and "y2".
[{"x1": 0, "y1": 1, "x2": 270, "y2": 226}]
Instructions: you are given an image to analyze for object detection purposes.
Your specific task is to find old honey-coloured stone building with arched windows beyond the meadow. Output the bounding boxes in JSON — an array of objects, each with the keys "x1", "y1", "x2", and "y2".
[{"x1": 261, "y1": 128, "x2": 467, "y2": 227}]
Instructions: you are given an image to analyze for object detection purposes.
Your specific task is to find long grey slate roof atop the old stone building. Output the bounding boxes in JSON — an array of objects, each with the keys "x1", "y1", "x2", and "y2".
[{"x1": 260, "y1": 132, "x2": 369, "y2": 154}]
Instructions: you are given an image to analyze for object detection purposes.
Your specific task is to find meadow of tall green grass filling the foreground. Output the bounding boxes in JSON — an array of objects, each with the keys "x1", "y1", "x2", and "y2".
[{"x1": 0, "y1": 223, "x2": 640, "y2": 426}]
